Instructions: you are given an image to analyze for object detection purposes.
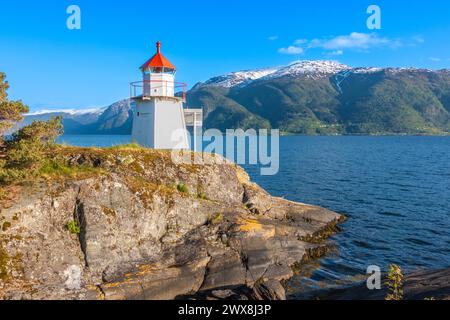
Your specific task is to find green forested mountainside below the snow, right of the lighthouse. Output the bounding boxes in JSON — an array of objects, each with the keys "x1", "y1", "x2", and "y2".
[{"x1": 188, "y1": 70, "x2": 450, "y2": 135}]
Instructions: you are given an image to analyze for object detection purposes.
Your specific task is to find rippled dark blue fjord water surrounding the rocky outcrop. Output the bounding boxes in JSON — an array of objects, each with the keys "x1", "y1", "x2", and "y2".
[{"x1": 61, "y1": 136, "x2": 450, "y2": 299}]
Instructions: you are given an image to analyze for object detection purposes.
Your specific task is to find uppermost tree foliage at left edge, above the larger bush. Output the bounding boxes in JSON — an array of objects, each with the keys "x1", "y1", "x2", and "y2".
[{"x1": 0, "y1": 72, "x2": 29, "y2": 144}]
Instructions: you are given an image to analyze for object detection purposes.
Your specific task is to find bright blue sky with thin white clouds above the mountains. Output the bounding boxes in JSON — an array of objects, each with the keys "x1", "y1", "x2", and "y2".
[{"x1": 0, "y1": 0, "x2": 450, "y2": 110}]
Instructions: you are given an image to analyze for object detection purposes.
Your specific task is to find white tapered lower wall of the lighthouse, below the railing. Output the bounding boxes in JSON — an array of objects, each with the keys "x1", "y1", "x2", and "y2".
[{"x1": 133, "y1": 98, "x2": 189, "y2": 150}]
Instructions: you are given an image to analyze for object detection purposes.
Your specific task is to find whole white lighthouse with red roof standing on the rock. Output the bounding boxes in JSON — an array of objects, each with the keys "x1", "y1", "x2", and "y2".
[{"x1": 131, "y1": 41, "x2": 189, "y2": 149}]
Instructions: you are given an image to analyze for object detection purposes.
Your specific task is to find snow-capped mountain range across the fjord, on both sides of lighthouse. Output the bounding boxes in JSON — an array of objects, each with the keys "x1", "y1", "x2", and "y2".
[{"x1": 26, "y1": 61, "x2": 450, "y2": 134}]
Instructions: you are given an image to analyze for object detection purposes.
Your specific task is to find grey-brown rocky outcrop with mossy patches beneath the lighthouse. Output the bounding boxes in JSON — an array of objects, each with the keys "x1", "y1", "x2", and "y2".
[{"x1": 0, "y1": 147, "x2": 341, "y2": 299}]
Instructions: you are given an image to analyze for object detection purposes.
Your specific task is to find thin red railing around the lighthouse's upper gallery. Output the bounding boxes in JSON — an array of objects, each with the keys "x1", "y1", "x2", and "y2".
[{"x1": 130, "y1": 80, "x2": 187, "y2": 101}]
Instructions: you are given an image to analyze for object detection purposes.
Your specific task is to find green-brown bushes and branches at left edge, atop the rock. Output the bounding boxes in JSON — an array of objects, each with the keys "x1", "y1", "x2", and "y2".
[{"x1": 0, "y1": 73, "x2": 100, "y2": 200}]
